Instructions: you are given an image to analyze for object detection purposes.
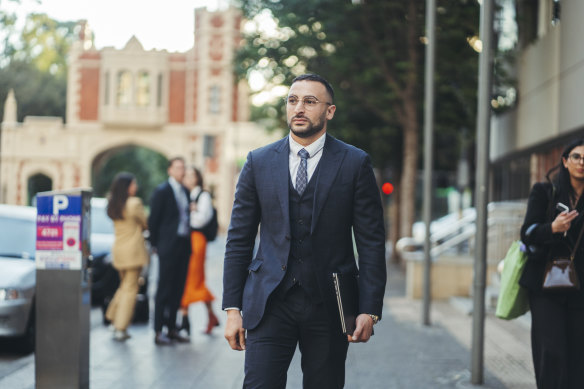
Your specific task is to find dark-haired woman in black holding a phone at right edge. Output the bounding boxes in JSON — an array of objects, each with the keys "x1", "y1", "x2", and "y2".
[{"x1": 520, "y1": 139, "x2": 584, "y2": 389}]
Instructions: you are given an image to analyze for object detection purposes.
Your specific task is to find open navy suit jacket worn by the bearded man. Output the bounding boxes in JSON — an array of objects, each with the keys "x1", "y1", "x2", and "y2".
[{"x1": 223, "y1": 134, "x2": 386, "y2": 329}]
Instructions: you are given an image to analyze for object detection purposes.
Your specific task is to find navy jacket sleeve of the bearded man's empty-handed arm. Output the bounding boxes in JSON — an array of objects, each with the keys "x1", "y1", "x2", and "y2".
[{"x1": 222, "y1": 153, "x2": 260, "y2": 309}]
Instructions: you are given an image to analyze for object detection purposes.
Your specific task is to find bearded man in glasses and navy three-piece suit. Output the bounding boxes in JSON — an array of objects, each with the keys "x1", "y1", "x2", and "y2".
[{"x1": 223, "y1": 74, "x2": 386, "y2": 389}]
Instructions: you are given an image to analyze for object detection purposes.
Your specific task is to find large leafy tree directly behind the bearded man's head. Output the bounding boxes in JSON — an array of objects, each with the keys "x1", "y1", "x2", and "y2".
[{"x1": 235, "y1": 0, "x2": 479, "y2": 253}]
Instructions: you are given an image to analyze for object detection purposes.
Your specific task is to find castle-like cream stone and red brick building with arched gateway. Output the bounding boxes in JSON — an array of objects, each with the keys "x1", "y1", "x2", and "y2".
[{"x1": 0, "y1": 8, "x2": 278, "y2": 227}]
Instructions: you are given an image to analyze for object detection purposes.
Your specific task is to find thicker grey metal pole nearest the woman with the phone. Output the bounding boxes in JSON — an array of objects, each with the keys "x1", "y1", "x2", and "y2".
[{"x1": 471, "y1": 0, "x2": 493, "y2": 385}]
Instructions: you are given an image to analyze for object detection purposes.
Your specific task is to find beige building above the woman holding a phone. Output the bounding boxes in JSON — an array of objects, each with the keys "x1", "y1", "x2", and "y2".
[{"x1": 490, "y1": 0, "x2": 584, "y2": 201}]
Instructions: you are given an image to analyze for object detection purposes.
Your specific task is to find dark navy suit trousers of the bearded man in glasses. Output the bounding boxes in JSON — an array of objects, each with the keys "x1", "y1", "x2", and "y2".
[{"x1": 243, "y1": 286, "x2": 349, "y2": 389}]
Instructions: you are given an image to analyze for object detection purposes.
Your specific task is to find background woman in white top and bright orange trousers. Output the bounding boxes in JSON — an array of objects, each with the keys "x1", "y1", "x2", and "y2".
[{"x1": 180, "y1": 166, "x2": 219, "y2": 335}]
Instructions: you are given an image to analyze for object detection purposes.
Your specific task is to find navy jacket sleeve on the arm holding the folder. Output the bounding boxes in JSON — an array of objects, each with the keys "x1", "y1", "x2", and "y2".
[{"x1": 353, "y1": 156, "x2": 387, "y2": 317}]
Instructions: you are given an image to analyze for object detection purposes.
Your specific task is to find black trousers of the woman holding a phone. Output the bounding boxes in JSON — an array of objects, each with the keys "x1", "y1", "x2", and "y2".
[{"x1": 529, "y1": 291, "x2": 584, "y2": 389}]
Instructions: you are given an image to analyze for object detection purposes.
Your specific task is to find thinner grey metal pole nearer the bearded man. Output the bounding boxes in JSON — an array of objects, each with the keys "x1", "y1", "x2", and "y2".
[{"x1": 422, "y1": 0, "x2": 436, "y2": 326}]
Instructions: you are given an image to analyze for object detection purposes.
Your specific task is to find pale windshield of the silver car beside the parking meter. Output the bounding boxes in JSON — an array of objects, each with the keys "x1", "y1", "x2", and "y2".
[{"x1": 0, "y1": 216, "x2": 36, "y2": 259}]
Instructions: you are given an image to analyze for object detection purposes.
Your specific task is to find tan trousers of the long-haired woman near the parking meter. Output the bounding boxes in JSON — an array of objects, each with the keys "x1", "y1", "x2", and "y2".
[{"x1": 105, "y1": 267, "x2": 142, "y2": 331}]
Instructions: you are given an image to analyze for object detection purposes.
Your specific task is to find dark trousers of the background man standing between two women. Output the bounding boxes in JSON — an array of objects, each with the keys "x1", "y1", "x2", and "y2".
[{"x1": 154, "y1": 237, "x2": 191, "y2": 332}]
